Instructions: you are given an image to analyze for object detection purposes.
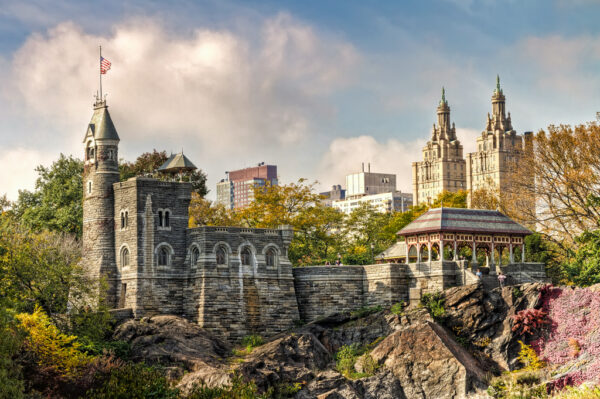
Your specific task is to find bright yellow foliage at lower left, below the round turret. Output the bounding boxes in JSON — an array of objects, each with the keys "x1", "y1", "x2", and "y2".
[{"x1": 16, "y1": 306, "x2": 94, "y2": 377}]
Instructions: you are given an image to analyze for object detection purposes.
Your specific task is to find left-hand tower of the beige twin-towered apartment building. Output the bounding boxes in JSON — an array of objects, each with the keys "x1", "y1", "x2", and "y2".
[{"x1": 412, "y1": 88, "x2": 466, "y2": 205}]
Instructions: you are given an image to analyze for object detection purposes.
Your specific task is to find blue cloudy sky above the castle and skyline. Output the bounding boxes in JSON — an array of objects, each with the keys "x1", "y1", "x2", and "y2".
[{"x1": 0, "y1": 0, "x2": 600, "y2": 200}]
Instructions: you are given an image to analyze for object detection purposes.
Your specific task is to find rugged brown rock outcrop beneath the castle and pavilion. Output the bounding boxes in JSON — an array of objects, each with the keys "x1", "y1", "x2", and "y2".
[{"x1": 109, "y1": 284, "x2": 542, "y2": 399}]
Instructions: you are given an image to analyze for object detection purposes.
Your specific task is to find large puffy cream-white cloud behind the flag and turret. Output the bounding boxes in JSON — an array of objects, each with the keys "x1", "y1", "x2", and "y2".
[{"x1": 0, "y1": 13, "x2": 360, "y2": 198}]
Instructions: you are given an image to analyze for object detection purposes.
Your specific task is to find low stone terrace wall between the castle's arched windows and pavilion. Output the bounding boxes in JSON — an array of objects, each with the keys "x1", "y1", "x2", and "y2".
[{"x1": 293, "y1": 264, "x2": 408, "y2": 322}]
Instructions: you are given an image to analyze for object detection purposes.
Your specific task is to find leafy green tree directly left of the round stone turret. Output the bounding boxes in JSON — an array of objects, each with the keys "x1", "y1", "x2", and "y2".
[{"x1": 13, "y1": 154, "x2": 83, "y2": 237}]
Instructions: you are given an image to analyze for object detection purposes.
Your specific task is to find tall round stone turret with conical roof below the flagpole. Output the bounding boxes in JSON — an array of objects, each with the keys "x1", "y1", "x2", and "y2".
[{"x1": 82, "y1": 99, "x2": 119, "y2": 307}]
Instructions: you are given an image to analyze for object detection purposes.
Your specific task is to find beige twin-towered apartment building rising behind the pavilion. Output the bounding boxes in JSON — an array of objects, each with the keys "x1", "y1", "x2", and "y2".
[{"x1": 412, "y1": 77, "x2": 531, "y2": 204}]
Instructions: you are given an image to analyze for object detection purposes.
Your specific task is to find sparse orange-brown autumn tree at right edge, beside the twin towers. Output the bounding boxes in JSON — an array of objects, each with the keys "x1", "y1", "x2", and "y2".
[{"x1": 513, "y1": 123, "x2": 600, "y2": 252}]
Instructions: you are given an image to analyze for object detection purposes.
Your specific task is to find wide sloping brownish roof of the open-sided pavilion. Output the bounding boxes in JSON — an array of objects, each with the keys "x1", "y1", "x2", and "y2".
[{"x1": 397, "y1": 208, "x2": 531, "y2": 236}]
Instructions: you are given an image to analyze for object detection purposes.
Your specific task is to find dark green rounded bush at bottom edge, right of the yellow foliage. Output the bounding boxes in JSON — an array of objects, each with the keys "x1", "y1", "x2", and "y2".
[{"x1": 85, "y1": 363, "x2": 178, "y2": 399}]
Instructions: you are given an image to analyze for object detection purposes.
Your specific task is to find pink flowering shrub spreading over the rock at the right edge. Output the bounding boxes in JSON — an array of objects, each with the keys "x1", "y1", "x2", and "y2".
[{"x1": 531, "y1": 287, "x2": 600, "y2": 389}]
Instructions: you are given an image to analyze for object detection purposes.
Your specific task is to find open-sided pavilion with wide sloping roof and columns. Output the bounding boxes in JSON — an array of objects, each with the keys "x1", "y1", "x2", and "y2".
[{"x1": 397, "y1": 207, "x2": 532, "y2": 265}]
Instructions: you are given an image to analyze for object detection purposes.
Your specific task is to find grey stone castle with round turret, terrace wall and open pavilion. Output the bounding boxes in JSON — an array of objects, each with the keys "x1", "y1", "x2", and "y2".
[{"x1": 82, "y1": 99, "x2": 545, "y2": 341}]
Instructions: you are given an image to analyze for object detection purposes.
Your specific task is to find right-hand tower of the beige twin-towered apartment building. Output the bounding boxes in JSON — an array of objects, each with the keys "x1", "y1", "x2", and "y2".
[{"x1": 466, "y1": 77, "x2": 530, "y2": 205}]
